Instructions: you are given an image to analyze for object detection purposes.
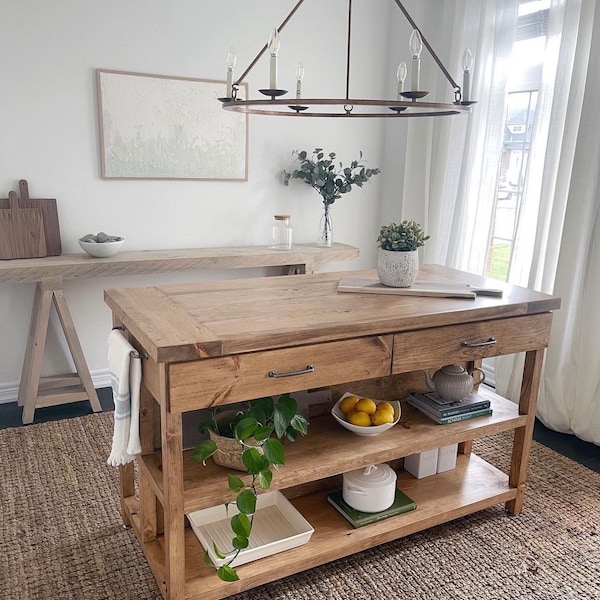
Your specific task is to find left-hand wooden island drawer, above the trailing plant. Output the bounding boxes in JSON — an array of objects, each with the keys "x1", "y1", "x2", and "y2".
[{"x1": 169, "y1": 335, "x2": 393, "y2": 412}]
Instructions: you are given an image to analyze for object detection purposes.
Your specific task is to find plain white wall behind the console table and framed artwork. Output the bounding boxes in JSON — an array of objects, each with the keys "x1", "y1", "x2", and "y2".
[{"x1": 0, "y1": 0, "x2": 408, "y2": 400}]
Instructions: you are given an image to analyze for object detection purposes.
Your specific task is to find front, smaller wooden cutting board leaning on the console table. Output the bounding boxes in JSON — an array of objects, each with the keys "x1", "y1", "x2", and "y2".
[{"x1": 0, "y1": 192, "x2": 47, "y2": 259}]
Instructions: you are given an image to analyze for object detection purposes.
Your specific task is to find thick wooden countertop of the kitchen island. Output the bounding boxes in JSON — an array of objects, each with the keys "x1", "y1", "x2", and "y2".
[{"x1": 104, "y1": 265, "x2": 560, "y2": 363}]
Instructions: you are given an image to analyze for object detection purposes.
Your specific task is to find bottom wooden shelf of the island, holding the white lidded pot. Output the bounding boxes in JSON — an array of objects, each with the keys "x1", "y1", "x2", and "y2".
[{"x1": 129, "y1": 454, "x2": 517, "y2": 600}]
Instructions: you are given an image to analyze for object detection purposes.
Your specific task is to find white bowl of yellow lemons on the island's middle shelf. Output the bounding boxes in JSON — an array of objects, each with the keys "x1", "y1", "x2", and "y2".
[{"x1": 331, "y1": 392, "x2": 402, "y2": 435}]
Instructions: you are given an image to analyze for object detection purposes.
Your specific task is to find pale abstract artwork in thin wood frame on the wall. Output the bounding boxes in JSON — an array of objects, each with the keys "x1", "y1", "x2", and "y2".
[{"x1": 96, "y1": 69, "x2": 248, "y2": 181}]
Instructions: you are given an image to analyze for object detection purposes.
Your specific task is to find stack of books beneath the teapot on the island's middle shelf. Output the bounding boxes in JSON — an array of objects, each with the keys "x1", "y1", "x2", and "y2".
[{"x1": 408, "y1": 392, "x2": 492, "y2": 425}]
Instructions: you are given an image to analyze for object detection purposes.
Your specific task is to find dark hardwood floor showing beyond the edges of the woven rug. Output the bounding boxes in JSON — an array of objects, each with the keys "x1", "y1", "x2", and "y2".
[{"x1": 0, "y1": 388, "x2": 600, "y2": 473}]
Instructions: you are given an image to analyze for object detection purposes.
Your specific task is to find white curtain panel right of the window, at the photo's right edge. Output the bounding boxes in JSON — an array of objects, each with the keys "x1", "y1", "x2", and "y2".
[{"x1": 496, "y1": 0, "x2": 600, "y2": 444}]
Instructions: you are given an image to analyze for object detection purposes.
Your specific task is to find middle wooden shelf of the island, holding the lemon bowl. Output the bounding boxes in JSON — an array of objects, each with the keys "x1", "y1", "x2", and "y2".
[{"x1": 140, "y1": 391, "x2": 527, "y2": 512}]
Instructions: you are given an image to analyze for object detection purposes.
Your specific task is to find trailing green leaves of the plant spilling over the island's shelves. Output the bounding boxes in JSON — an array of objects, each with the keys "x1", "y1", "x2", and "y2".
[{"x1": 192, "y1": 394, "x2": 308, "y2": 581}]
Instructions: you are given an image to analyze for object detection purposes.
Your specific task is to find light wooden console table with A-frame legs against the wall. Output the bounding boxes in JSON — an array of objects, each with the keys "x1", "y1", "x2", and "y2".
[{"x1": 0, "y1": 244, "x2": 359, "y2": 423}]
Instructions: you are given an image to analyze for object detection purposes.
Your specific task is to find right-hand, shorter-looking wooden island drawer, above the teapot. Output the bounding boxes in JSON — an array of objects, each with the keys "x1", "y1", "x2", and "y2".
[{"x1": 392, "y1": 313, "x2": 552, "y2": 374}]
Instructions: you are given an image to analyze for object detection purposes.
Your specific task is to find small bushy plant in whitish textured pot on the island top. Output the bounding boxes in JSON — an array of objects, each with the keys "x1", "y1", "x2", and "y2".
[{"x1": 377, "y1": 221, "x2": 429, "y2": 287}]
